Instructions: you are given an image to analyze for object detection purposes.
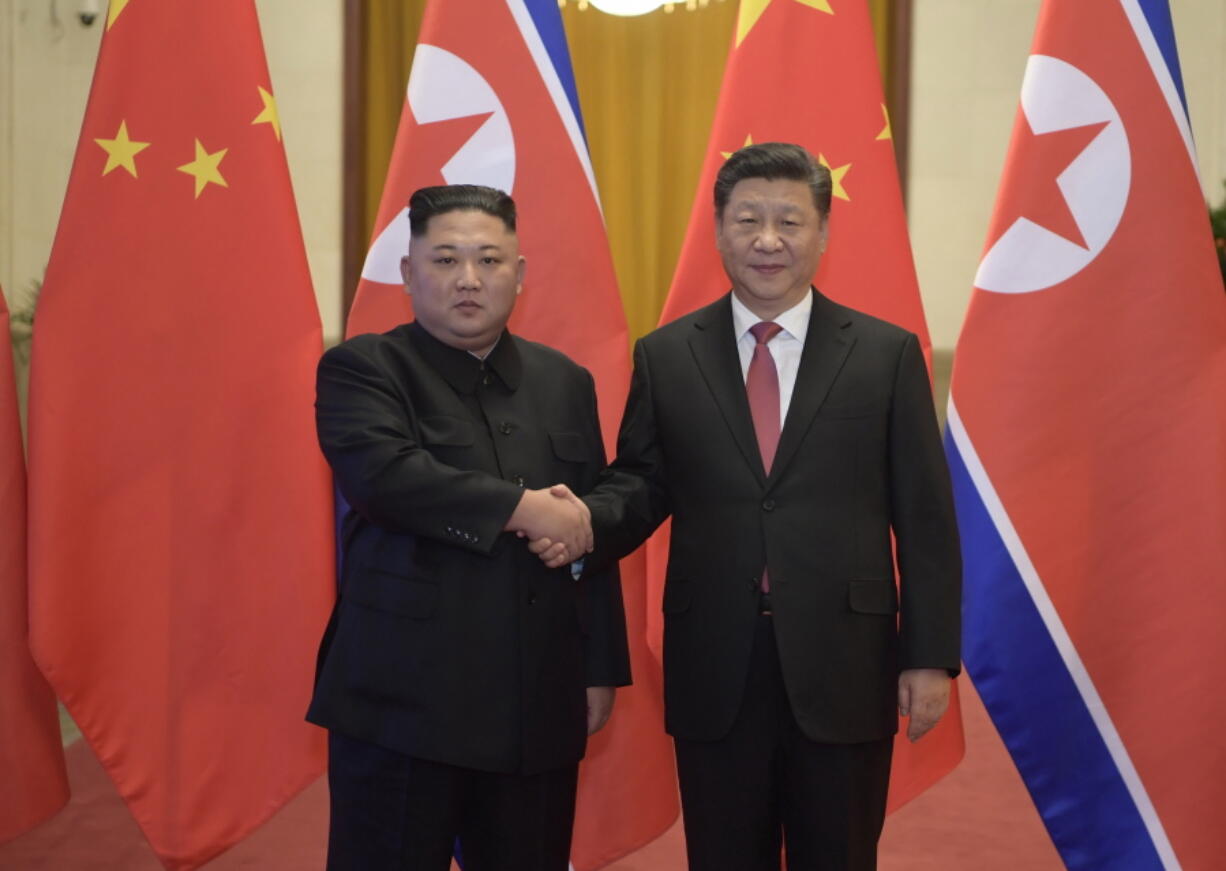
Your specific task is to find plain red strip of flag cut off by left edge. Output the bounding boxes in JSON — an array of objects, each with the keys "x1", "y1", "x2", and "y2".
[{"x1": 0, "y1": 293, "x2": 69, "y2": 843}]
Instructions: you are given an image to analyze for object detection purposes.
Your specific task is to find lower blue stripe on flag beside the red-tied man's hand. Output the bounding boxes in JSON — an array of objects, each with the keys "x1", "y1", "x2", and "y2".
[{"x1": 945, "y1": 432, "x2": 1162, "y2": 871}]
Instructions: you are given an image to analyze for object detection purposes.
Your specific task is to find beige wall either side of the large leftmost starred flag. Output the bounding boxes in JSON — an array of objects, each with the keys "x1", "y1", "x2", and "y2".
[{"x1": 0, "y1": 0, "x2": 342, "y2": 341}]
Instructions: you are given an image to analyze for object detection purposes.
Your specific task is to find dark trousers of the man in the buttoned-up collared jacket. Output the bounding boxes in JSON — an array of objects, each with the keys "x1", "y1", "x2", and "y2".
[{"x1": 327, "y1": 731, "x2": 579, "y2": 871}]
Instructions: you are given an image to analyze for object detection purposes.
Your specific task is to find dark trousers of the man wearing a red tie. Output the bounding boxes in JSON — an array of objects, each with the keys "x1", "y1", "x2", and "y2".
[{"x1": 676, "y1": 616, "x2": 894, "y2": 871}]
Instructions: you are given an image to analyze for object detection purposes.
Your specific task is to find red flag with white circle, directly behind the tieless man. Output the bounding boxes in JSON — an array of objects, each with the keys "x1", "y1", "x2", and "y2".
[{"x1": 348, "y1": 0, "x2": 678, "y2": 871}]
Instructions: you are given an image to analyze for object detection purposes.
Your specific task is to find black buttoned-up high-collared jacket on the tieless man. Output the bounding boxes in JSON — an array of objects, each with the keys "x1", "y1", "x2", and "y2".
[{"x1": 308, "y1": 323, "x2": 630, "y2": 773}]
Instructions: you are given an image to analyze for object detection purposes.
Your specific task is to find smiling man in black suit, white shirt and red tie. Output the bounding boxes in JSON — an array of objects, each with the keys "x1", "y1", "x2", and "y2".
[{"x1": 568, "y1": 144, "x2": 961, "y2": 871}]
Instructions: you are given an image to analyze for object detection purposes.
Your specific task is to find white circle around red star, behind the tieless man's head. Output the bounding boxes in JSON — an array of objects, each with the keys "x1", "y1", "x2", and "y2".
[{"x1": 362, "y1": 43, "x2": 515, "y2": 285}]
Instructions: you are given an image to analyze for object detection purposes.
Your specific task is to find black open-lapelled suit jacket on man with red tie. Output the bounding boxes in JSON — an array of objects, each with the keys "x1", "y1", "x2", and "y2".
[{"x1": 587, "y1": 291, "x2": 961, "y2": 743}]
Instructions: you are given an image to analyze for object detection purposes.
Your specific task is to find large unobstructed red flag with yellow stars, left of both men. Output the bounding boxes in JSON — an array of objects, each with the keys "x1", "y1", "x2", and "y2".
[{"x1": 29, "y1": 0, "x2": 335, "y2": 869}]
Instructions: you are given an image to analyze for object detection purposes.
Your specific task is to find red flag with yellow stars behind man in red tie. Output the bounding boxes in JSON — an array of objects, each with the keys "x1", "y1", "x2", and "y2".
[{"x1": 647, "y1": 0, "x2": 962, "y2": 810}]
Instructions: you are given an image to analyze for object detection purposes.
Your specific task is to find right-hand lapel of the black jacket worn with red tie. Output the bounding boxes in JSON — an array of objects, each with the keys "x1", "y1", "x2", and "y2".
[{"x1": 769, "y1": 291, "x2": 856, "y2": 482}]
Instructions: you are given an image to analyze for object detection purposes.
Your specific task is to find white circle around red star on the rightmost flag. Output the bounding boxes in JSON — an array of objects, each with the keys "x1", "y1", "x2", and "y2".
[{"x1": 975, "y1": 54, "x2": 1132, "y2": 293}]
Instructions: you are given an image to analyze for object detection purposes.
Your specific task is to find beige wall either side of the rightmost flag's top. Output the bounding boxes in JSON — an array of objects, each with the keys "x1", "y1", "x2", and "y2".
[{"x1": 907, "y1": 0, "x2": 1226, "y2": 350}]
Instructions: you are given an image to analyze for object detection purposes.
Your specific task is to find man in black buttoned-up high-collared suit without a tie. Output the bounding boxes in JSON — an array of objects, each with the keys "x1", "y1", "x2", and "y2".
[{"x1": 308, "y1": 185, "x2": 630, "y2": 871}]
